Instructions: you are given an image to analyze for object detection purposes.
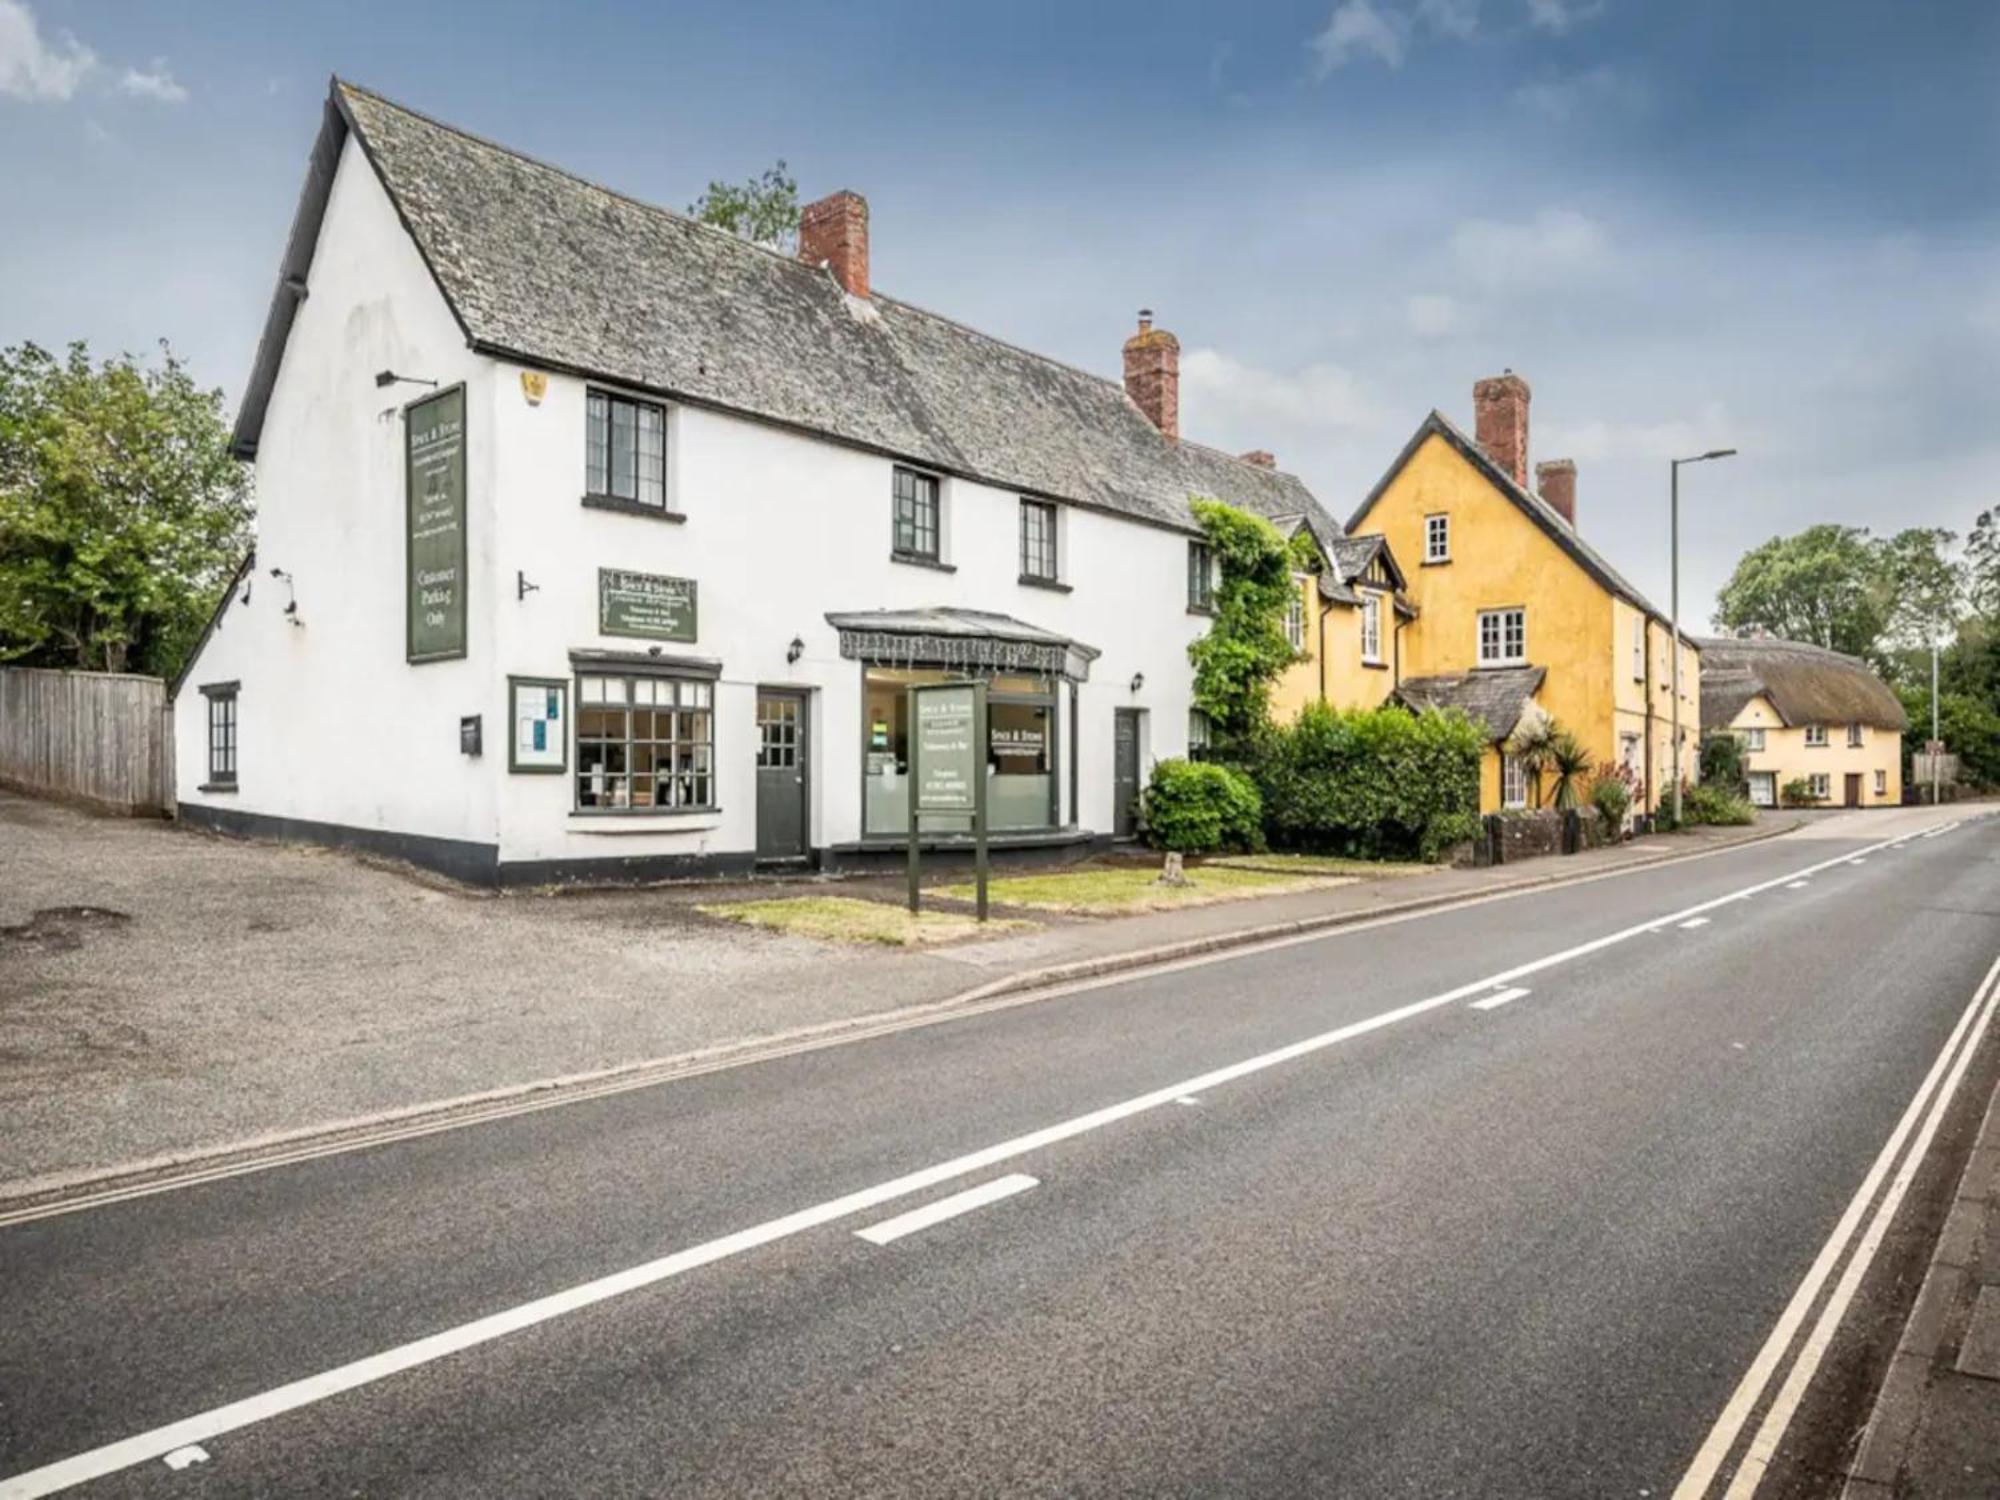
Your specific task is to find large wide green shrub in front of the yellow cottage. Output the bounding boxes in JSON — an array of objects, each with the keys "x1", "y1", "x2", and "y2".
[{"x1": 1254, "y1": 704, "x2": 1486, "y2": 860}]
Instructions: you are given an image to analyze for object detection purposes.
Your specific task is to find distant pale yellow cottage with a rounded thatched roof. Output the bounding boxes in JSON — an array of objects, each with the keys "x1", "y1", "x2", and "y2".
[{"x1": 1702, "y1": 640, "x2": 1908, "y2": 808}]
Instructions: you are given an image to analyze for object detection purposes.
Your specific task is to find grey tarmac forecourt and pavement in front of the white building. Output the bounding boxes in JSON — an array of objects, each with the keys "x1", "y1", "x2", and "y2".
[{"x1": 0, "y1": 792, "x2": 1790, "y2": 1202}]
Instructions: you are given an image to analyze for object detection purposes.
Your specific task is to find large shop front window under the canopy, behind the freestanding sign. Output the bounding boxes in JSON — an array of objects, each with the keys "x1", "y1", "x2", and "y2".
[{"x1": 862, "y1": 666, "x2": 1056, "y2": 838}]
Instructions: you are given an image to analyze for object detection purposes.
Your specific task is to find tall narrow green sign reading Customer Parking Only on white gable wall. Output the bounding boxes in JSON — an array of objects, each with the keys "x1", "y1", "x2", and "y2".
[{"x1": 404, "y1": 386, "x2": 466, "y2": 662}]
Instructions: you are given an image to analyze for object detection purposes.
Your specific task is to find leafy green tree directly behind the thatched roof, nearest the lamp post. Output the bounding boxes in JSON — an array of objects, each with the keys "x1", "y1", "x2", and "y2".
[{"x1": 1716, "y1": 524, "x2": 1888, "y2": 656}]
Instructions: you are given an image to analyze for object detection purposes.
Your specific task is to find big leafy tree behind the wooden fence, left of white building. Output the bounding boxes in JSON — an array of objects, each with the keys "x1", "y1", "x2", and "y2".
[{"x1": 0, "y1": 342, "x2": 252, "y2": 676}]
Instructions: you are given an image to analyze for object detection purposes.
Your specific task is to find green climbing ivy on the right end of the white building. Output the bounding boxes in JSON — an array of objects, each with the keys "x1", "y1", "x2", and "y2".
[{"x1": 1188, "y1": 500, "x2": 1312, "y2": 754}]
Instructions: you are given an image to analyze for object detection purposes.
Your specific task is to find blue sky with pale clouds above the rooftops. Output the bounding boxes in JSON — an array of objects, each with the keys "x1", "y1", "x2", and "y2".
[{"x1": 0, "y1": 0, "x2": 2000, "y2": 622}]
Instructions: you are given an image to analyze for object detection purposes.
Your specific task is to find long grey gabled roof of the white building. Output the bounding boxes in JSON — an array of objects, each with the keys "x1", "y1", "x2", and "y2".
[{"x1": 236, "y1": 78, "x2": 1340, "y2": 548}]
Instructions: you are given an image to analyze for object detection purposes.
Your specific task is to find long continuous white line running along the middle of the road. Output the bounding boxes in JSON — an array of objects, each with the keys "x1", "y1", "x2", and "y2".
[{"x1": 0, "y1": 828, "x2": 1912, "y2": 1500}]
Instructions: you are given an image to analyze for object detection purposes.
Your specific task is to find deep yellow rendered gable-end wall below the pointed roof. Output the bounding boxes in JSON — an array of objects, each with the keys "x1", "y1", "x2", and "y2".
[{"x1": 1360, "y1": 434, "x2": 1630, "y2": 764}]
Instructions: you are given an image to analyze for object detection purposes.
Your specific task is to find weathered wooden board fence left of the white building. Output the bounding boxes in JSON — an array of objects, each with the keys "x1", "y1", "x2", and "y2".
[{"x1": 0, "y1": 666, "x2": 174, "y2": 814}]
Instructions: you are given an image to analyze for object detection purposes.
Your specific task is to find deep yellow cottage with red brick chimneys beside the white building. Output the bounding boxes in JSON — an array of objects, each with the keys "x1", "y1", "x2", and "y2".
[{"x1": 1328, "y1": 382, "x2": 1702, "y2": 812}]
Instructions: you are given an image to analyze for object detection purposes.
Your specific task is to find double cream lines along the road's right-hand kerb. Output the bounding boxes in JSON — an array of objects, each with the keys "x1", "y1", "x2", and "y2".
[{"x1": 1674, "y1": 958, "x2": 2000, "y2": 1500}]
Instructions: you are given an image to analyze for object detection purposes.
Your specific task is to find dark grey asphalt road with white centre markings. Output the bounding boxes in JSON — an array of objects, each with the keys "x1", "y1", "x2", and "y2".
[{"x1": 0, "y1": 810, "x2": 2000, "y2": 1500}]
